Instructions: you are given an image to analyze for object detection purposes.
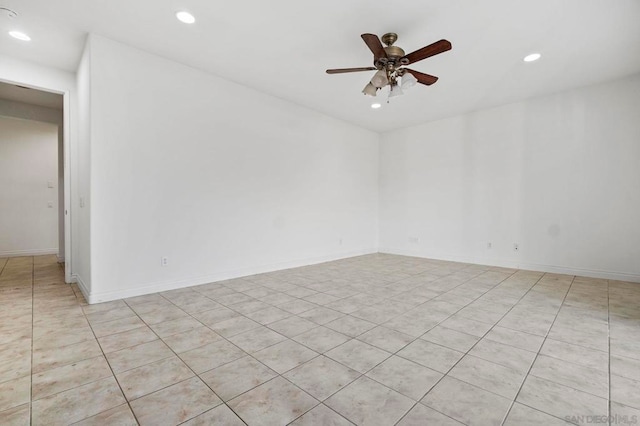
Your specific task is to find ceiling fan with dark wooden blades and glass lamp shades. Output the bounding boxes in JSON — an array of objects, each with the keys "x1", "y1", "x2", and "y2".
[{"x1": 327, "y1": 33, "x2": 451, "y2": 97}]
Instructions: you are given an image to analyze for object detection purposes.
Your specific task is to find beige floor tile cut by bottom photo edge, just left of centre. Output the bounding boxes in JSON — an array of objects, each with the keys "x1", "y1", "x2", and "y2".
[{"x1": 229, "y1": 377, "x2": 318, "y2": 426}]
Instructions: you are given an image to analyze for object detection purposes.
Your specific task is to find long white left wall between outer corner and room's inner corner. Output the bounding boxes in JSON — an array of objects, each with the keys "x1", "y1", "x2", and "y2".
[{"x1": 82, "y1": 36, "x2": 378, "y2": 302}]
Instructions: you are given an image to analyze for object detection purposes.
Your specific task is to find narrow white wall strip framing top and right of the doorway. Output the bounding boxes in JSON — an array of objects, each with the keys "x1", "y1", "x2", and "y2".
[{"x1": 0, "y1": 55, "x2": 79, "y2": 281}]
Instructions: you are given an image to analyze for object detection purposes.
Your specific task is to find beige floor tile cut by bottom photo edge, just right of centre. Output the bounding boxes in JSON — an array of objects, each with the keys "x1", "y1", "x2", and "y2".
[{"x1": 325, "y1": 377, "x2": 414, "y2": 425}]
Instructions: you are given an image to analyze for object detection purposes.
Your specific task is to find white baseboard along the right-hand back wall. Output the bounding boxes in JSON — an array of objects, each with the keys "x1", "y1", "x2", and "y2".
[{"x1": 379, "y1": 247, "x2": 640, "y2": 283}]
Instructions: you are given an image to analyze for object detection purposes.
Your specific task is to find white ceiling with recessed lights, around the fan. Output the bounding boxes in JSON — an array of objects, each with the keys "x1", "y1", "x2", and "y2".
[{"x1": 0, "y1": 0, "x2": 640, "y2": 131}]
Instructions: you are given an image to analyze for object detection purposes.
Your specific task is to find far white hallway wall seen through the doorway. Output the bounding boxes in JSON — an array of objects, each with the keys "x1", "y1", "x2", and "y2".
[{"x1": 0, "y1": 116, "x2": 58, "y2": 256}]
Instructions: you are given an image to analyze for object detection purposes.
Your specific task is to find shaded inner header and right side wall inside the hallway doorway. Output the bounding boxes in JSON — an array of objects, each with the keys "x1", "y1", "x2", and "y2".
[{"x1": 0, "y1": 99, "x2": 65, "y2": 261}]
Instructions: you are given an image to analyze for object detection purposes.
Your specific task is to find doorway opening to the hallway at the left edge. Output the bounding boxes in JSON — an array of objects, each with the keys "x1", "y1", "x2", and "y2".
[{"x1": 0, "y1": 81, "x2": 71, "y2": 282}]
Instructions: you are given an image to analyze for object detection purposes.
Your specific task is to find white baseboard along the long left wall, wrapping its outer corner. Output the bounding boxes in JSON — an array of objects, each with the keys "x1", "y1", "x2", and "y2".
[{"x1": 82, "y1": 248, "x2": 378, "y2": 304}]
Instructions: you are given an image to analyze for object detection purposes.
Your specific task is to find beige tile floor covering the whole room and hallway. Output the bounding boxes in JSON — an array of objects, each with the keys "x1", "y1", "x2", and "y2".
[{"x1": 0, "y1": 254, "x2": 640, "y2": 426}]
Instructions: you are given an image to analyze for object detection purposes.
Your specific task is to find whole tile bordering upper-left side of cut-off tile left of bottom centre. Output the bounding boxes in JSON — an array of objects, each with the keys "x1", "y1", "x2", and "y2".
[{"x1": 200, "y1": 356, "x2": 278, "y2": 401}]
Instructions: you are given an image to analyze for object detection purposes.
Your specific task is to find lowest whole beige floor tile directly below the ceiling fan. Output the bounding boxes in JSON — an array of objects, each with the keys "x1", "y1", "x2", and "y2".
[{"x1": 367, "y1": 356, "x2": 443, "y2": 401}]
